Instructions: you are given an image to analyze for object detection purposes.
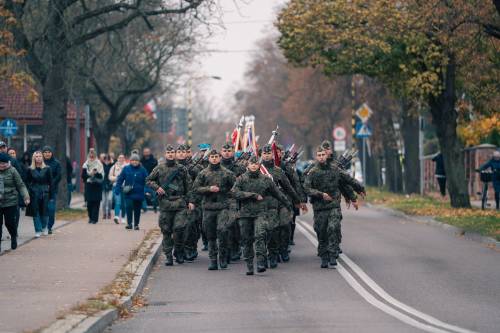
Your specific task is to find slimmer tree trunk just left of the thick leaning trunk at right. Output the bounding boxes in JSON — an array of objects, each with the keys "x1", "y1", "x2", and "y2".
[{"x1": 401, "y1": 101, "x2": 420, "y2": 194}]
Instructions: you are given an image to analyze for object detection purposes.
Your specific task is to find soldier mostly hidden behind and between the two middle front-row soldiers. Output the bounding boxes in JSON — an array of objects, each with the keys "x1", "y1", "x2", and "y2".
[{"x1": 221, "y1": 143, "x2": 246, "y2": 262}]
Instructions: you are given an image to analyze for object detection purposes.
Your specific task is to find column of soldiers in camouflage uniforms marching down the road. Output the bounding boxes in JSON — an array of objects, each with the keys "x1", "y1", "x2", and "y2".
[{"x1": 147, "y1": 141, "x2": 365, "y2": 275}]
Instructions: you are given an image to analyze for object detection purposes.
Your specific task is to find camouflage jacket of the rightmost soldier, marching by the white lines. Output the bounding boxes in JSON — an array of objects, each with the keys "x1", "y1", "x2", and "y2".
[{"x1": 304, "y1": 163, "x2": 357, "y2": 210}]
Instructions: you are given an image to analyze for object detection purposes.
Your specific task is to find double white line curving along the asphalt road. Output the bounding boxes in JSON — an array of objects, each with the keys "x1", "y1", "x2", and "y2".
[{"x1": 297, "y1": 220, "x2": 473, "y2": 333}]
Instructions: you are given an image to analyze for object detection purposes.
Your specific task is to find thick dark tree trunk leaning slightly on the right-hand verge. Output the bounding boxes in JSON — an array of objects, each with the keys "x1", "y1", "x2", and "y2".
[{"x1": 429, "y1": 56, "x2": 471, "y2": 208}]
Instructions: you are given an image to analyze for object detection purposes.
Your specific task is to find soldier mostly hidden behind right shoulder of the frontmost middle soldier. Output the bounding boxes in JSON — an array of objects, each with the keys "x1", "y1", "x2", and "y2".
[{"x1": 262, "y1": 144, "x2": 305, "y2": 268}]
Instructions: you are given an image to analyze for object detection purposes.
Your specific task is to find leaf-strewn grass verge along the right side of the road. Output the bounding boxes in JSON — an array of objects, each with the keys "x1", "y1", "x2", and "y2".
[{"x1": 365, "y1": 187, "x2": 500, "y2": 241}]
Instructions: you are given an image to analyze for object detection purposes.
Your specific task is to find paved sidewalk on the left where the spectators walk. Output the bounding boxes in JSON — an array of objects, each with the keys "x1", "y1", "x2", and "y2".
[{"x1": 0, "y1": 212, "x2": 158, "y2": 333}]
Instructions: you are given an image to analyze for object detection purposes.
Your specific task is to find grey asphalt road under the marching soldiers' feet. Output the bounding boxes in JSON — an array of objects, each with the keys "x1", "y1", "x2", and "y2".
[{"x1": 108, "y1": 208, "x2": 500, "y2": 333}]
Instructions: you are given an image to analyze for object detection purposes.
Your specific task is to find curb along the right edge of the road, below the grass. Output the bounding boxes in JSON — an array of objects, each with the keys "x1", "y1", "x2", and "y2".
[{"x1": 365, "y1": 202, "x2": 500, "y2": 251}]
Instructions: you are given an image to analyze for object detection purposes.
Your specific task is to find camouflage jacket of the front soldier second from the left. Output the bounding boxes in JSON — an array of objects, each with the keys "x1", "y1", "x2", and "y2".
[{"x1": 193, "y1": 164, "x2": 236, "y2": 210}]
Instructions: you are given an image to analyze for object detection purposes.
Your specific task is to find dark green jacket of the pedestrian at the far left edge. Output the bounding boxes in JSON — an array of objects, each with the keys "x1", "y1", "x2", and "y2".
[{"x1": 0, "y1": 166, "x2": 30, "y2": 208}]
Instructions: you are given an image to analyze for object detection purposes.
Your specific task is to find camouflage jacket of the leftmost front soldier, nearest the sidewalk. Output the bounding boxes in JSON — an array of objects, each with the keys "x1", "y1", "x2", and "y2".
[{"x1": 146, "y1": 161, "x2": 192, "y2": 211}]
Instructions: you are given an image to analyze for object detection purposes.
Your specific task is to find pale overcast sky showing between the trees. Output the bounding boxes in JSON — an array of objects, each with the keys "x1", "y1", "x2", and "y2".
[{"x1": 188, "y1": 0, "x2": 286, "y2": 116}]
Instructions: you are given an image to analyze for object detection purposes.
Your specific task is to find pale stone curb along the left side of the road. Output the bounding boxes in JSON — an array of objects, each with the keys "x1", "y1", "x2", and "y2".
[{"x1": 40, "y1": 236, "x2": 162, "y2": 333}]
